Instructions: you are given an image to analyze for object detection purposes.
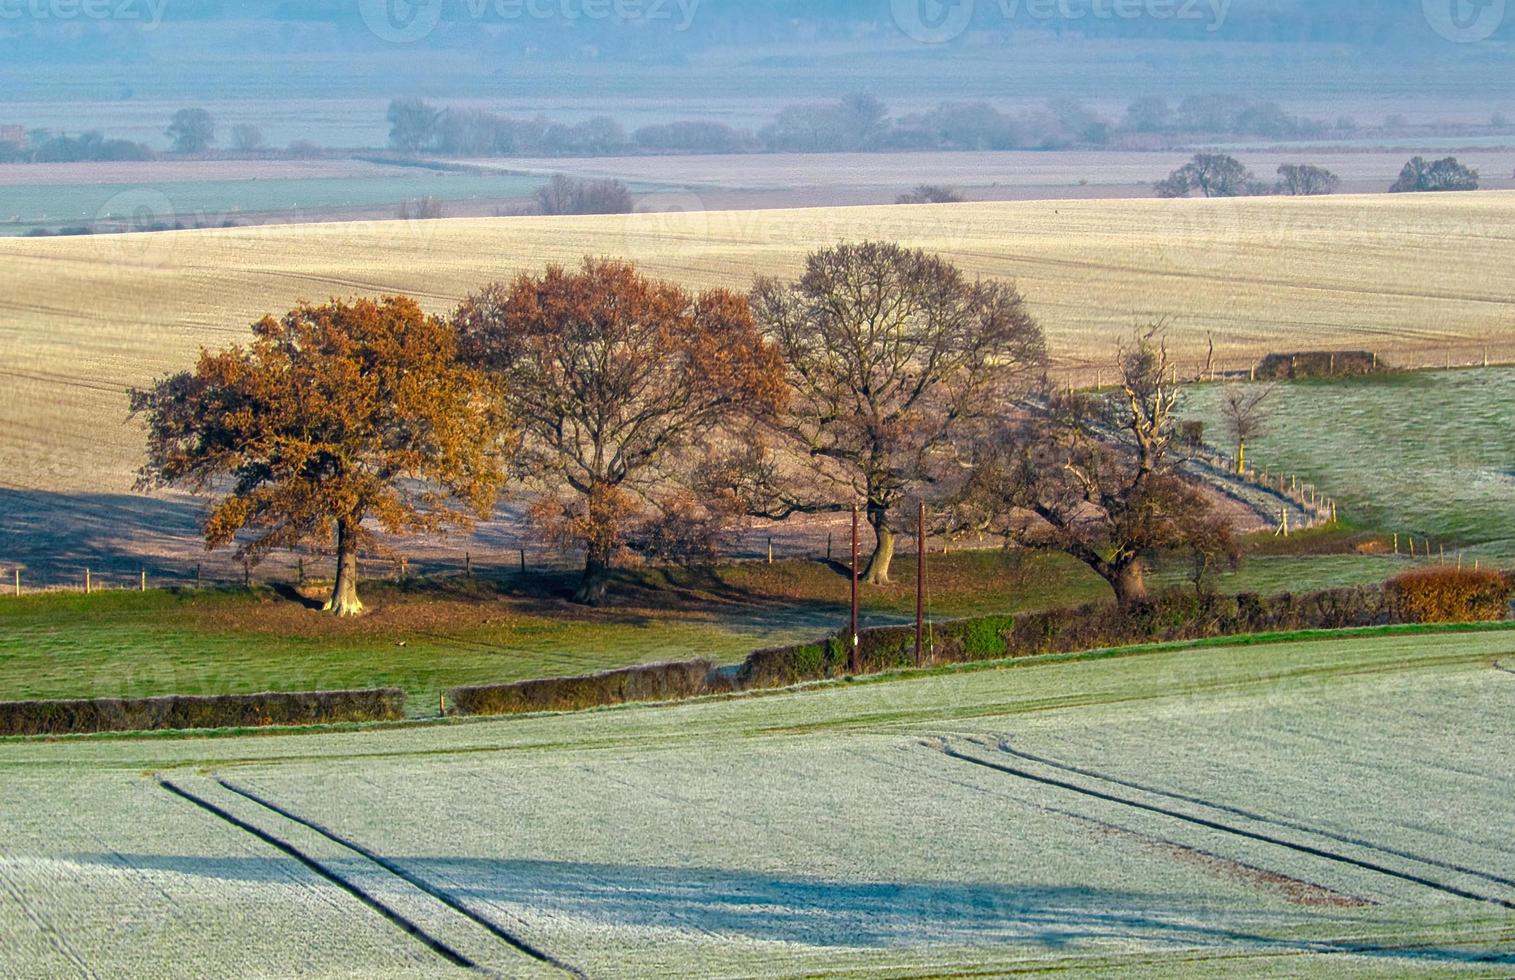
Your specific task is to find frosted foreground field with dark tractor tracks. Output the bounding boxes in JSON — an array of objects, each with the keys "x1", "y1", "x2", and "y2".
[{"x1": 0, "y1": 632, "x2": 1515, "y2": 977}]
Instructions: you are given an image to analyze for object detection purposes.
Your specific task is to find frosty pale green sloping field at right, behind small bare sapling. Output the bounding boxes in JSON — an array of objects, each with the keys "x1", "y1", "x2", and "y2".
[{"x1": 1186, "y1": 368, "x2": 1515, "y2": 560}]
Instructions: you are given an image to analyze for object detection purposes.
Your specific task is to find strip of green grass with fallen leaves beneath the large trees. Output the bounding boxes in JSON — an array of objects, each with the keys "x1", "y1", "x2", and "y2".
[{"x1": 0, "y1": 541, "x2": 1424, "y2": 713}]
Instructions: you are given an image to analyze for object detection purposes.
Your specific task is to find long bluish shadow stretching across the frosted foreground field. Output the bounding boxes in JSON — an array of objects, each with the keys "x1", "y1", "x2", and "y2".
[{"x1": 59, "y1": 854, "x2": 1515, "y2": 965}]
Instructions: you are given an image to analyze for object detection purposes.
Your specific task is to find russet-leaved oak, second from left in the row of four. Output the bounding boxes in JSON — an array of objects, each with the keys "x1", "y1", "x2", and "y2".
[{"x1": 455, "y1": 259, "x2": 783, "y2": 606}]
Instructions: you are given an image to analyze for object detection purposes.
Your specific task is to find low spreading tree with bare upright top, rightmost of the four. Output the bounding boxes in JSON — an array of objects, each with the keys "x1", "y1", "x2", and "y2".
[{"x1": 953, "y1": 327, "x2": 1233, "y2": 607}]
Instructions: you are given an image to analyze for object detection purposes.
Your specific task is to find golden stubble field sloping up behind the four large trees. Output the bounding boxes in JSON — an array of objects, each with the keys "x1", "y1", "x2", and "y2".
[{"x1": 0, "y1": 192, "x2": 1515, "y2": 514}]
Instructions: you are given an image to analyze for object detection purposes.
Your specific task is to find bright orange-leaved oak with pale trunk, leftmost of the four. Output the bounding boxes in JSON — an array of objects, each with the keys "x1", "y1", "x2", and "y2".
[{"x1": 132, "y1": 297, "x2": 509, "y2": 616}]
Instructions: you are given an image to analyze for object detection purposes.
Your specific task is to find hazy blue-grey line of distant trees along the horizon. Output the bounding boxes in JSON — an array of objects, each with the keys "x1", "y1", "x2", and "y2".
[{"x1": 386, "y1": 92, "x2": 1411, "y2": 156}]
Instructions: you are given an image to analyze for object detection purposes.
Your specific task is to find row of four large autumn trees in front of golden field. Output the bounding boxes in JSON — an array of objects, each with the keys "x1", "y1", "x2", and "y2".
[{"x1": 132, "y1": 242, "x2": 1230, "y2": 615}]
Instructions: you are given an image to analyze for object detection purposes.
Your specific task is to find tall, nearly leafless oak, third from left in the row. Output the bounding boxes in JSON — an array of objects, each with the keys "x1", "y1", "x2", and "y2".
[{"x1": 747, "y1": 242, "x2": 1045, "y2": 585}]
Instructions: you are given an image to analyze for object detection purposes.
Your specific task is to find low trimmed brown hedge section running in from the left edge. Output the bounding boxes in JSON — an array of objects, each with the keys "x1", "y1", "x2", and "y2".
[{"x1": 0, "y1": 689, "x2": 405, "y2": 736}]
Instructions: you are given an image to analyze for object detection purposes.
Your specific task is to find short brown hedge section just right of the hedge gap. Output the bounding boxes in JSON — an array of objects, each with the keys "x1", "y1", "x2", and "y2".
[{"x1": 448, "y1": 660, "x2": 715, "y2": 715}]
